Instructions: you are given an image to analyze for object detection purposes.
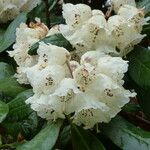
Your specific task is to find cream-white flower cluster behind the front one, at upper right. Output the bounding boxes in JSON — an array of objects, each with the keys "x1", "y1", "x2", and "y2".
[{"x1": 60, "y1": 0, "x2": 150, "y2": 56}]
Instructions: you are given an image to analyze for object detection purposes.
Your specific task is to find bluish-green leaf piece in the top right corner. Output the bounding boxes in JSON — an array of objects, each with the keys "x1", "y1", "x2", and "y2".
[{"x1": 137, "y1": 0, "x2": 150, "y2": 14}]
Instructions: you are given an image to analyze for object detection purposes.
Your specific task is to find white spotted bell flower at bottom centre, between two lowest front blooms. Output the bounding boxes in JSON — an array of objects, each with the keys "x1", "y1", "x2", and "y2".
[{"x1": 50, "y1": 78, "x2": 81, "y2": 115}]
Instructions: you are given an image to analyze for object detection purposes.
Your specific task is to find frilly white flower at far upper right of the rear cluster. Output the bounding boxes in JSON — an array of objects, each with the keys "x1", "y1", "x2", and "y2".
[{"x1": 118, "y1": 5, "x2": 150, "y2": 32}]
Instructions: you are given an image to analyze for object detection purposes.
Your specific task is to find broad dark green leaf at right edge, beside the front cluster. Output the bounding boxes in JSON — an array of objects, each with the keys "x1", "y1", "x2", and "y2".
[{"x1": 128, "y1": 46, "x2": 150, "y2": 88}]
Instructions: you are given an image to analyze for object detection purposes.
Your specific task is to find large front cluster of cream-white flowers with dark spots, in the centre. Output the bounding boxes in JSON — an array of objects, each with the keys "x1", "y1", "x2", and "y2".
[{"x1": 25, "y1": 42, "x2": 135, "y2": 128}]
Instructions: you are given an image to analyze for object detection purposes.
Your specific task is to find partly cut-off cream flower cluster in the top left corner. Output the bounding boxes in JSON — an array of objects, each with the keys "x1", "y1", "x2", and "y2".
[{"x1": 0, "y1": 0, "x2": 41, "y2": 22}]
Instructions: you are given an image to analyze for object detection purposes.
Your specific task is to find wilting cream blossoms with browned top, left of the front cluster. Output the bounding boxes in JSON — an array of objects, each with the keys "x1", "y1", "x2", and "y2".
[{"x1": 8, "y1": 22, "x2": 48, "y2": 84}]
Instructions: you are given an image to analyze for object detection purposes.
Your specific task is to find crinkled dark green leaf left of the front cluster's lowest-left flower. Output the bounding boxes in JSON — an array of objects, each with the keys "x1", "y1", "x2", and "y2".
[{"x1": 2, "y1": 90, "x2": 33, "y2": 137}]
